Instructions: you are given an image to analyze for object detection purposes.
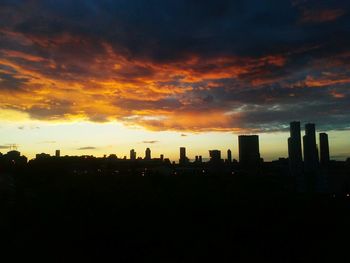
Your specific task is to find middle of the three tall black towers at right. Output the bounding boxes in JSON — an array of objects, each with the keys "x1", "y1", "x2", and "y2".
[{"x1": 303, "y1": 123, "x2": 318, "y2": 173}]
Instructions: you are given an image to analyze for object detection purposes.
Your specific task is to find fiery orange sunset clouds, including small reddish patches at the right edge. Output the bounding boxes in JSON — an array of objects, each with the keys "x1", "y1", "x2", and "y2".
[{"x1": 0, "y1": 25, "x2": 349, "y2": 132}]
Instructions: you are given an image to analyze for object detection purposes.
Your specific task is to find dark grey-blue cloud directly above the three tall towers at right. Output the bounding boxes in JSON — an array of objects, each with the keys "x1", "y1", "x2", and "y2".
[{"x1": 187, "y1": 79, "x2": 350, "y2": 132}]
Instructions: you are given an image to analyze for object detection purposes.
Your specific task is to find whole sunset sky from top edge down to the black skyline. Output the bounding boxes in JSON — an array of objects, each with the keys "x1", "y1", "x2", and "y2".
[{"x1": 0, "y1": 0, "x2": 350, "y2": 160}]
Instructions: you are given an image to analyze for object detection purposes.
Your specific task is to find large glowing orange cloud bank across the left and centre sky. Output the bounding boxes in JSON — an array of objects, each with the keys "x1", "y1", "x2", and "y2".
[{"x1": 0, "y1": 41, "x2": 318, "y2": 131}]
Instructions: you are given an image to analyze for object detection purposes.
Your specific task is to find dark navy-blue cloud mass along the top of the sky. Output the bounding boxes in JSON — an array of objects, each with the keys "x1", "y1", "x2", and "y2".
[{"x1": 3, "y1": 0, "x2": 349, "y2": 61}]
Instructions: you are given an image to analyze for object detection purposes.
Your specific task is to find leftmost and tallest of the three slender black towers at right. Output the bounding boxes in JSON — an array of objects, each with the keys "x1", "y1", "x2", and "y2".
[{"x1": 288, "y1": 121, "x2": 303, "y2": 175}]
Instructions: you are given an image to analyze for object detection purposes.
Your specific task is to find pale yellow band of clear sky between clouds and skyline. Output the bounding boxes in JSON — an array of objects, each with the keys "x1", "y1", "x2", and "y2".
[{"x1": 0, "y1": 117, "x2": 350, "y2": 162}]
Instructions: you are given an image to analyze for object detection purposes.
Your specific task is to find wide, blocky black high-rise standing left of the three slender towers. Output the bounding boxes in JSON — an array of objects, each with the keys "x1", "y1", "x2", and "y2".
[{"x1": 238, "y1": 135, "x2": 260, "y2": 167}]
